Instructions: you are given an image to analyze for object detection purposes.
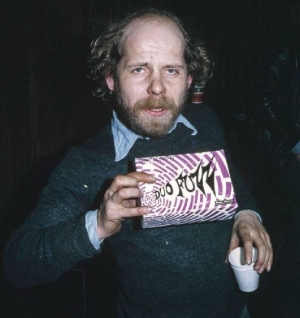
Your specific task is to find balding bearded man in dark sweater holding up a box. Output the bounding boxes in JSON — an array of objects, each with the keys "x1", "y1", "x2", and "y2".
[{"x1": 6, "y1": 10, "x2": 272, "y2": 318}]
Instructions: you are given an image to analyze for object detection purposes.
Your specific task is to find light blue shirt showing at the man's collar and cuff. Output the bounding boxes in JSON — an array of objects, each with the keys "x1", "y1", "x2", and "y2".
[{"x1": 85, "y1": 111, "x2": 197, "y2": 250}]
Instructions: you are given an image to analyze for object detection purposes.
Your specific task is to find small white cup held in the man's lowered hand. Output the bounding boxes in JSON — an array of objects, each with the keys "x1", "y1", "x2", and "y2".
[{"x1": 229, "y1": 247, "x2": 260, "y2": 292}]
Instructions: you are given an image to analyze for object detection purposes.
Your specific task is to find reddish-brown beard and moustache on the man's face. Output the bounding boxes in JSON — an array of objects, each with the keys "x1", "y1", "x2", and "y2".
[{"x1": 116, "y1": 86, "x2": 187, "y2": 138}]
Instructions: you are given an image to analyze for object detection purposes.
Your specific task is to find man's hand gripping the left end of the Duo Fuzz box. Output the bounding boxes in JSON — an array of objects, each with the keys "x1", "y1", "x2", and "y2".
[{"x1": 97, "y1": 172, "x2": 155, "y2": 239}]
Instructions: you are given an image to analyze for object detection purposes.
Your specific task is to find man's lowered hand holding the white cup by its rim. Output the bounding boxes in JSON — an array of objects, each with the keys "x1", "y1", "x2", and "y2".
[{"x1": 226, "y1": 210, "x2": 273, "y2": 274}]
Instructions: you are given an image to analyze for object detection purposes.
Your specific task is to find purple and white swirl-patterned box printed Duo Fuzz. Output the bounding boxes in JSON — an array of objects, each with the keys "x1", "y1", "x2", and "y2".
[{"x1": 135, "y1": 150, "x2": 238, "y2": 228}]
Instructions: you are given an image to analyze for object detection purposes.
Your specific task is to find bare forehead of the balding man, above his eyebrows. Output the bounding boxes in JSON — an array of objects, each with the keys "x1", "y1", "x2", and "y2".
[{"x1": 123, "y1": 17, "x2": 185, "y2": 57}]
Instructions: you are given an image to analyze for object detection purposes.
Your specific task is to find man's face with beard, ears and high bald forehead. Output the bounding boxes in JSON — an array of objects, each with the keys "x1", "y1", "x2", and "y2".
[{"x1": 106, "y1": 19, "x2": 192, "y2": 138}]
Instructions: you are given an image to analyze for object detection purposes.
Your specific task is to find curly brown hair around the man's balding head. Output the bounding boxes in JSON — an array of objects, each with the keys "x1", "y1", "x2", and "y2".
[{"x1": 88, "y1": 9, "x2": 213, "y2": 100}]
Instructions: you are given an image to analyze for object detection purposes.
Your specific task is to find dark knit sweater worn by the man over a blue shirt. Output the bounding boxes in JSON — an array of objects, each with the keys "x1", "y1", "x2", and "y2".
[{"x1": 5, "y1": 105, "x2": 255, "y2": 318}]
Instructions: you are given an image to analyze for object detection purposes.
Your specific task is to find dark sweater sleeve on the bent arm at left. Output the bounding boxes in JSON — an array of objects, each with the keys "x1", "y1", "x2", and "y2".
[{"x1": 4, "y1": 148, "x2": 100, "y2": 288}]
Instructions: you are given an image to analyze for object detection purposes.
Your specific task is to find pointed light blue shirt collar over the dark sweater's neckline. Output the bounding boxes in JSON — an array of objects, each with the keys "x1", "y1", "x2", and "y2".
[{"x1": 111, "y1": 111, "x2": 197, "y2": 161}]
